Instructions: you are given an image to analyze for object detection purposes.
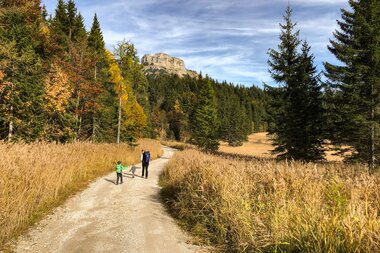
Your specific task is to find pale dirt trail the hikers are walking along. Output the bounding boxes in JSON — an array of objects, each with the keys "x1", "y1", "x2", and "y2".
[{"x1": 15, "y1": 147, "x2": 205, "y2": 253}]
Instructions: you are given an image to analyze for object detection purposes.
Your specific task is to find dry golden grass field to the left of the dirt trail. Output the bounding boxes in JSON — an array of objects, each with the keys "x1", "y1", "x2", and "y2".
[{"x1": 0, "y1": 140, "x2": 162, "y2": 249}]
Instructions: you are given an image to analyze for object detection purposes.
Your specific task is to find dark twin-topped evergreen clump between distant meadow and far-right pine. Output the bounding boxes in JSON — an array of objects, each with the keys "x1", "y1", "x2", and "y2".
[{"x1": 267, "y1": 6, "x2": 323, "y2": 161}]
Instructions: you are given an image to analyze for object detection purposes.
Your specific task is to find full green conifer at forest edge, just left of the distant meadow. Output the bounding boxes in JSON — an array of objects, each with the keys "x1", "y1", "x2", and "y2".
[{"x1": 191, "y1": 76, "x2": 219, "y2": 151}]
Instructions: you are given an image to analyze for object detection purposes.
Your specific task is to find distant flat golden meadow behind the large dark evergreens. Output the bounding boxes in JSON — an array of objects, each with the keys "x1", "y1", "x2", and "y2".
[{"x1": 219, "y1": 132, "x2": 343, "y2": 161}]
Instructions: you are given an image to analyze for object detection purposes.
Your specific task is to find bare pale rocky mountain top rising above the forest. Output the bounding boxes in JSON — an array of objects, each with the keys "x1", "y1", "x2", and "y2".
[{"x1": 141, "y1": 53, "x2": 198, "y2": 77}]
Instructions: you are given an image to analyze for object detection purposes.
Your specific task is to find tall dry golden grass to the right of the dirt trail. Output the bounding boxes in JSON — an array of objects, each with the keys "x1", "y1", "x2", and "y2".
[{"x1": 162, "y1": 150, "x2": 380, "y2": 252}]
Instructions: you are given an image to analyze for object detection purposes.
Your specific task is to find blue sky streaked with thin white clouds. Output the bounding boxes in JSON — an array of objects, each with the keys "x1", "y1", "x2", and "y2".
[{"x1": 42, "y1": 0, "x2": 348, "y2": 86}]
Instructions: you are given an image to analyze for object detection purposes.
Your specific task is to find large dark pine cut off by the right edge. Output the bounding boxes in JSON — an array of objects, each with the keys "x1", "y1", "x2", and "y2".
[{"x1": 325, "y1": 0, "x2": 380, "y2": 171}]
